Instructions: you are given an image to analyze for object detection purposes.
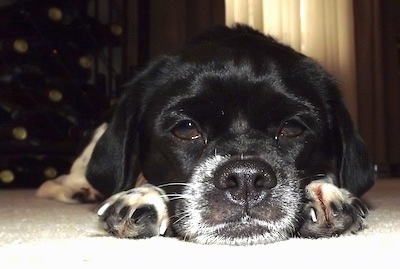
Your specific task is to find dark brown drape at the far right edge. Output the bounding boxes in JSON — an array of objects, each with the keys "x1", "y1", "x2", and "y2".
[{"x1": 354, "y1": 0, "x2": 400, "y2": 164}]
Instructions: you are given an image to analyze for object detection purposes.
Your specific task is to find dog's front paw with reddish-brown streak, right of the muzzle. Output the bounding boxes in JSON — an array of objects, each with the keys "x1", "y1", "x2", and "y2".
[{"x1": 299, "y1": 181, "x2": 368, "y2": 238}]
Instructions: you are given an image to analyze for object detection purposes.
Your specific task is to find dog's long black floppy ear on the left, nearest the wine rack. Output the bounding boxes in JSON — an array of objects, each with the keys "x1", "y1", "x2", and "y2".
[{"x1": 86, "y1": 57, "x2": 174, "y2": 197}]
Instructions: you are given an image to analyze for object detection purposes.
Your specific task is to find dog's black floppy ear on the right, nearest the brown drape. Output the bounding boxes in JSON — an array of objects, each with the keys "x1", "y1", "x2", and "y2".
[{"x1": 333, "y1": 100, "x2": 375, "y2": 196}]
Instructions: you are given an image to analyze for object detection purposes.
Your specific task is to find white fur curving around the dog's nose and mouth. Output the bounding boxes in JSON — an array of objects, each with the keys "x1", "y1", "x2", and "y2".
[{"x1": 178, "y1": 155, "x2": 300, "y2": 245}]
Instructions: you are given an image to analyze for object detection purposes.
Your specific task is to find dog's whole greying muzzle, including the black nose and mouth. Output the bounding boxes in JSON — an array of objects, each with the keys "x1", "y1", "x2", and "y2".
[{"x1": 174, "y1": 155, "x2": 301, "y2": 245}]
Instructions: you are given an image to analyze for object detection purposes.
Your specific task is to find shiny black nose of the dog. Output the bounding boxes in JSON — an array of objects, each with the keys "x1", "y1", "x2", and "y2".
[{"x1": 214, "y1": 159, "x2": 277, "y2": 202}]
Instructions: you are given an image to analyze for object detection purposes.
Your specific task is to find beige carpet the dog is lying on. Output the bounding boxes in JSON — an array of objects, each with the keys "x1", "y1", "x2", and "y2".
[{"x1": 0, "y1": 179, "x2": 400, "y2": 269}]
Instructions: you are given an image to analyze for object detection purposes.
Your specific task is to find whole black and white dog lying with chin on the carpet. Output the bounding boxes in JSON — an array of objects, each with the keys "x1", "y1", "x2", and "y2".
[{"x1": 38, "y1": 25, "x2": 375, "y2": 245}]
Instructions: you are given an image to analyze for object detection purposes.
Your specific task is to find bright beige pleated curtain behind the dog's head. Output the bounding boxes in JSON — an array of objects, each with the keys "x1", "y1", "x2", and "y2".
[{"x1": 225, "y1": 0, "x2": 358, "y2": 123}]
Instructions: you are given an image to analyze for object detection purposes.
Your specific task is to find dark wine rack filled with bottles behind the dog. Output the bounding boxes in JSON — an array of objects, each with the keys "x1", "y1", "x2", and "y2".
[{"x1": 0, "y1": 0, "x2": 126, "y2": 188}]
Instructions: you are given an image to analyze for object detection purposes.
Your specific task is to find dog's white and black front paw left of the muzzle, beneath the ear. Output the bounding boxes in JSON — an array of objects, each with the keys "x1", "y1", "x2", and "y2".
[{"x1": 97, "y1": 184, "x2": 169, "y2": 238}]
